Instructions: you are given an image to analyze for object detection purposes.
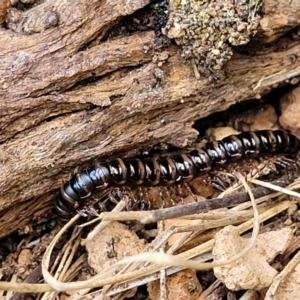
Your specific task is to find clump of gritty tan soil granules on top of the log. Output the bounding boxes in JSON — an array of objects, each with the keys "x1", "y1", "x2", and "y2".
[{"x1": 163, "y1": 0, "x2": 262, "y2": 79}]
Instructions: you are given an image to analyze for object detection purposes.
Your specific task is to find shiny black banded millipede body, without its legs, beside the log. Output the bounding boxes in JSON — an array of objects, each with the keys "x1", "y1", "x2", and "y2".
[{"x1": 56, "y1": 130, "x2": 300, "y2": 217}]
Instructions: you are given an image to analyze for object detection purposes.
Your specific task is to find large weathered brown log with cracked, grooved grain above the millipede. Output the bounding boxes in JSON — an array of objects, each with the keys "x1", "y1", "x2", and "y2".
[{"x1": 0, "y1": 0, "x2": 300, "y2": 237}]
